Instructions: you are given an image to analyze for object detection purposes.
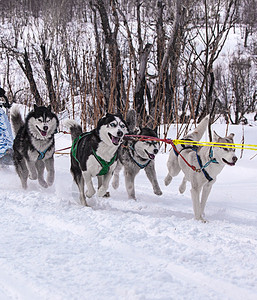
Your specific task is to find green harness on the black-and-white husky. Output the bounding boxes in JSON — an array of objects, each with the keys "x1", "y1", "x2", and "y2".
[{"x1": 71, "y1": 131, "x2": 117, "y2": 176}]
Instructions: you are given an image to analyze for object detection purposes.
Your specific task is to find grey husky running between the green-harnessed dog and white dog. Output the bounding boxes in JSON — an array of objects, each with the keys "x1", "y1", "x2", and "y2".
[{"x1": 112, "y1": 110, "x2": 162, "y2": 199}]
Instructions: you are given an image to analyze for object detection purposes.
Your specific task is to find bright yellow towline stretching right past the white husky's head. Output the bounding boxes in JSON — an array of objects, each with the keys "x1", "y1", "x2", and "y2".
[{"x1": 173, "y1": 140, "x2": 257, "y2": 150}]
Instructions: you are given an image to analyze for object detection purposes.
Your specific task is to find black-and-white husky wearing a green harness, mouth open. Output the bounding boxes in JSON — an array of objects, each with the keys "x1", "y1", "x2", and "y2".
[{"x1": 64, "y1": 113, "x2": 128, "y2": 206}]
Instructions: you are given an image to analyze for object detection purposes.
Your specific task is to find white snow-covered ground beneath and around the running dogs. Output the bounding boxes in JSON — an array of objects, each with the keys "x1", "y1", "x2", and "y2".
[{"x1": 0, "y1": 123, "x2": 257, "y2": 300}]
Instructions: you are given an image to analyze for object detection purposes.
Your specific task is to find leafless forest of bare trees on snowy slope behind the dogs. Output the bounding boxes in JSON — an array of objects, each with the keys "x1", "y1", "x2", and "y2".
[{"x1": 0, "y1": 0, "x2": 257, "y2": 129}]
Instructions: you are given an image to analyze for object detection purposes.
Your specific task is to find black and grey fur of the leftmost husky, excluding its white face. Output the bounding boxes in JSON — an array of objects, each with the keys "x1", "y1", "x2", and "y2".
[{"x1": 11, "y1": 105, "x2": 59, "y2": 189}]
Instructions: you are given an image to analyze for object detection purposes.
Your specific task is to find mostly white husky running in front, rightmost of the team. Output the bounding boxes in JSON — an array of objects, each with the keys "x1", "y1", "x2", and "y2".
[{"x1": 164, "y1": 116, "x2": 237, "y2": 223}]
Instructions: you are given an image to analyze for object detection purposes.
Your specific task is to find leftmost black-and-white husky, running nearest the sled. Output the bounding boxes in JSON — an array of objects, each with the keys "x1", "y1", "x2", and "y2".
[{"x1": 11, "y1": 105, "x2": 59, "y2": 189}]
